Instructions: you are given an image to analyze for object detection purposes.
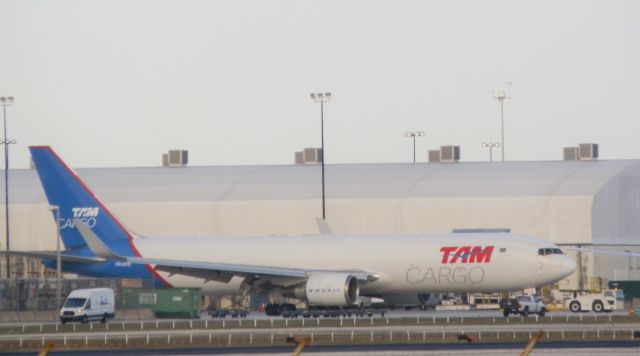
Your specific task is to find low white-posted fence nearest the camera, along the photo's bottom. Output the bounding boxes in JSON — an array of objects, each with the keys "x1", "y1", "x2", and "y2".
[{"x1": 0, "y1": 329, "x2": 640, "y2": 351}]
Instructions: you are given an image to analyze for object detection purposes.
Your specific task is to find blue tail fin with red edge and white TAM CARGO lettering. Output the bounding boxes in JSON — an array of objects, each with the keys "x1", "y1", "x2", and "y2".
[{"x1": 29, "y1": 146, "x2": 138, "y2": 256}]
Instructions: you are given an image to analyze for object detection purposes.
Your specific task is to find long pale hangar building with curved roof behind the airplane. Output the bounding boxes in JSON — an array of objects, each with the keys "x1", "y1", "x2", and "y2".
[{"x1": 0, "y1": 154, "x2": 640, "y2": 289}]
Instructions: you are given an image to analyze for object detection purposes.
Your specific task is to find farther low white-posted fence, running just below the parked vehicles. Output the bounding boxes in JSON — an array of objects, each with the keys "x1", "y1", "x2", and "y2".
[{"x1": 0, "y1": 315, "x2": 640, "y2": 338}]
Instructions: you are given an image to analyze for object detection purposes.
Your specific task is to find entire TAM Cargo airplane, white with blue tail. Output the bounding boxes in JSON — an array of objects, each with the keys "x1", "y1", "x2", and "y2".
[{"x1": 12, "y1": 146, "x2": 576, "y2": 306}]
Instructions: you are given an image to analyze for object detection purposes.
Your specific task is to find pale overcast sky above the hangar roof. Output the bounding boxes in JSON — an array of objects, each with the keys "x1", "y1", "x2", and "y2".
[{"x1": 0, "y1": 0, "x2": 640, "y2": 168}]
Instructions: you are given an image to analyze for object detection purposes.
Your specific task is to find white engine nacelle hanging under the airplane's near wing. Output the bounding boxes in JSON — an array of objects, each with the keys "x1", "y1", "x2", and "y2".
[{"x1": 294, "y1": 273, "x2": 360, "y2": 306}]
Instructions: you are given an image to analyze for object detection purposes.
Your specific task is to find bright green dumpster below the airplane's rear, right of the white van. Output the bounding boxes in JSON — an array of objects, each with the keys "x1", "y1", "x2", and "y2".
[{"x1": 153, "y1": 288, "x2": 202, "y2": 318}]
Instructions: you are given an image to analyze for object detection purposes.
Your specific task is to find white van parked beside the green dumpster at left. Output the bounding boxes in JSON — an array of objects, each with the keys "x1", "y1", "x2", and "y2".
[{"x1": 60, "y1": 288, "x2": 115, "y2": 324}]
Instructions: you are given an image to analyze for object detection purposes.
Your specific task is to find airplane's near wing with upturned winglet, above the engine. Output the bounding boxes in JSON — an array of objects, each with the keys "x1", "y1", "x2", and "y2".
[{"x1": 74, "y1": 219, "x2": 378, "y2": 286}]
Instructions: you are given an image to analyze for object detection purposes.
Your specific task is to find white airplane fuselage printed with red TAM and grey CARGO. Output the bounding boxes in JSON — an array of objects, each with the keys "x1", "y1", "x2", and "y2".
[{"x1": 134, "y1": 233, "x2": 576, "y2": 295}]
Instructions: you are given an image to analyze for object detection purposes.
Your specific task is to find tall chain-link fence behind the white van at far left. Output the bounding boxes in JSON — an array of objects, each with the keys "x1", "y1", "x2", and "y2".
[{"x1": 0, "y1": 278, "x2": 155, "y2": 312}]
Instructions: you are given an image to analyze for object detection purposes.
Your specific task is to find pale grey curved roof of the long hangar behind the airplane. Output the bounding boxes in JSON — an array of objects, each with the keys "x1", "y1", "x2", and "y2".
[{"x1": 8, "y1": 160, "x2": 640, "y2": 203}]
